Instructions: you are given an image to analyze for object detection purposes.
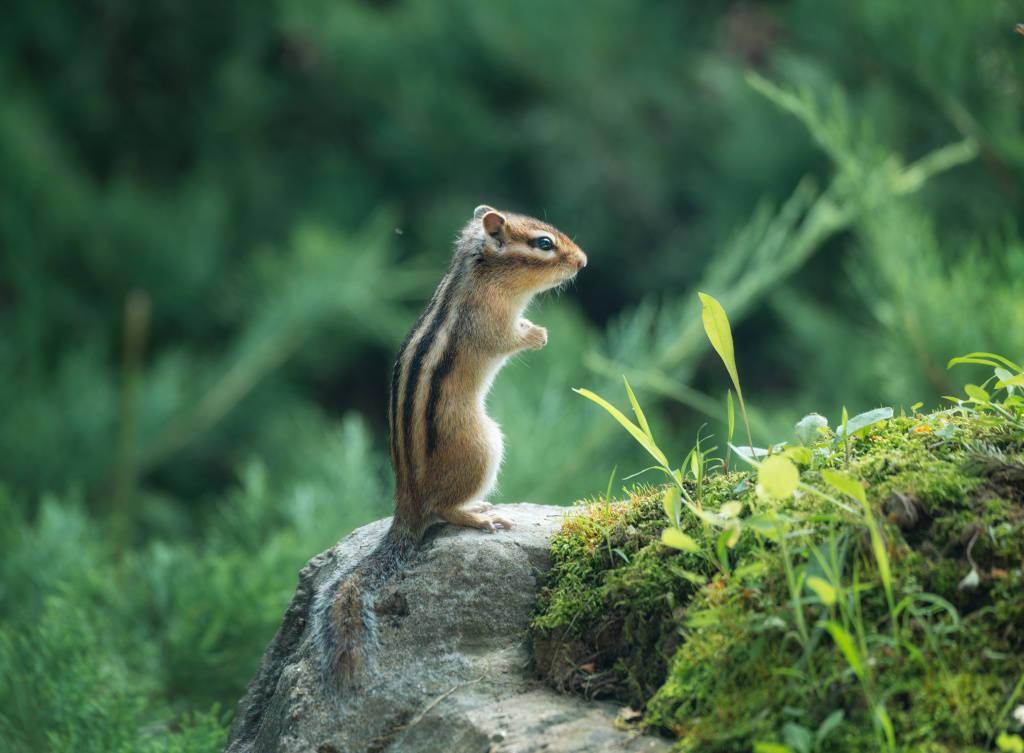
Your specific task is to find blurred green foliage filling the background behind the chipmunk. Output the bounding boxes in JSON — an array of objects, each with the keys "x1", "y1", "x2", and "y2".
[{"x1": 0, "y1": 0, "x2": 1024, "y2": 751}]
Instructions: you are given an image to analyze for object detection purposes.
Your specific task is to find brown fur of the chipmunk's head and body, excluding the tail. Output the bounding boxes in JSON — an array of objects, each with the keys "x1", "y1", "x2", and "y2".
[{"x1": 391, "y1": 207, "x2": 587, "y2": 531}]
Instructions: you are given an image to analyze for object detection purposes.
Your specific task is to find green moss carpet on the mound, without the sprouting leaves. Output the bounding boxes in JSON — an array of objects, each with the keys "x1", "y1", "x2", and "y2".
[{"x1": 534, "y1": 413, "x2": 1024, "y2": 753}]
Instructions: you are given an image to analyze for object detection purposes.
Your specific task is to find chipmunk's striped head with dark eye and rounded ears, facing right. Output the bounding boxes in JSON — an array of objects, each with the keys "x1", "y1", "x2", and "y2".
[{"x1": 459, "y1": 205, "x2": 587, "y2": 295}]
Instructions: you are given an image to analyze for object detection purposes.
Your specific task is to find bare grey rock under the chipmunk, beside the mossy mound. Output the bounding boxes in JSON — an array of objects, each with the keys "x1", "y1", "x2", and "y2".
[{"x1": 227, "y1": 504, "x2": 670, "y2": 753}]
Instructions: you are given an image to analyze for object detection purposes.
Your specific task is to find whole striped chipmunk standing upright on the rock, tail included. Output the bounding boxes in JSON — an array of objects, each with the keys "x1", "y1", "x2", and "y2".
[{"x1": 314, "y1": 205, "x2": 587, "y2": 687}]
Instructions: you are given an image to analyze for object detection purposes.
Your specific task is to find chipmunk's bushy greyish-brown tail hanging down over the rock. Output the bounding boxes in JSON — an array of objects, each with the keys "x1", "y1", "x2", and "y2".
[{"x1": 314, "y1": 522, "x2": 420, "y2": 689}]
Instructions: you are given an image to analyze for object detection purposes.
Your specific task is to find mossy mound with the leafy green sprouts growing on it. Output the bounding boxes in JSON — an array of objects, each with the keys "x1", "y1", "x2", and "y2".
[{"x1": 534, "y1": 303, "x2": 1024, "y2": 753}]
